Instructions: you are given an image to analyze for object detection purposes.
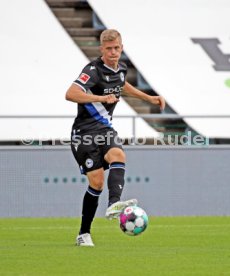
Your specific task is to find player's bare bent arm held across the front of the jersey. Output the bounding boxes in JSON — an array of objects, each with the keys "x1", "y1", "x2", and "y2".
[{"x1": 65, "y1": 84, "x2": 118, "y2": 104}]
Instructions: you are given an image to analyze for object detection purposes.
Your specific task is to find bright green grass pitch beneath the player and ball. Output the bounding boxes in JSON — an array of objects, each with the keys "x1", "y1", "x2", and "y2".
[{"x1": 0, "y1": 217, "x2": 230, "y2": 276}]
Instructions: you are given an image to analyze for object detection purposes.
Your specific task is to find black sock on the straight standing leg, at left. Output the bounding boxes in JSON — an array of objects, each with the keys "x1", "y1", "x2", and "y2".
[{"x1": 79, "y1": 186, "x2": 102, "y2": 235}]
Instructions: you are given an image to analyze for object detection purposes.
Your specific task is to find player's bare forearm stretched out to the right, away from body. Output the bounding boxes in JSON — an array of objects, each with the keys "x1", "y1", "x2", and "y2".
[{"x1": 123, "y1": 81, "x2": 165, "y2": 110}]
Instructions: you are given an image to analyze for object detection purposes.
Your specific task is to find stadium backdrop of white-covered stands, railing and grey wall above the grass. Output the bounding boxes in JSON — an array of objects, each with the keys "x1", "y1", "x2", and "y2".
[{"x1": 0, "y1": 0, "x2": 230, "y2": 217}]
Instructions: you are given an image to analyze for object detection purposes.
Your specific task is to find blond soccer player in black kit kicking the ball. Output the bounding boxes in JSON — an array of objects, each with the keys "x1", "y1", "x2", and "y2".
[{"x1": 66, "y1": 29, "x2": 165, "y2": 246}]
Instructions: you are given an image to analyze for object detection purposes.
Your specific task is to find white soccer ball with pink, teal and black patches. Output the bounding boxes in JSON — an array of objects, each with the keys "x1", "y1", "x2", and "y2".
[{"x1": 119, "y1": 206, "x2": 148, "y2": 236}]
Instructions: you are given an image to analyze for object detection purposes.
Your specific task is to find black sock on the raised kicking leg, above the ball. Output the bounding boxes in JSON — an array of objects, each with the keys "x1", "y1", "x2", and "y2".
[{"x1": 108, "y1": 162, "x2": 125, "y2": 206}]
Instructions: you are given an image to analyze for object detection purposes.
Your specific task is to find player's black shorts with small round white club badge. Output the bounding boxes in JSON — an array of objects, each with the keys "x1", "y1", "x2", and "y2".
[{"x1": 71, "y1": 128, "x2": 123, "y2": 174}]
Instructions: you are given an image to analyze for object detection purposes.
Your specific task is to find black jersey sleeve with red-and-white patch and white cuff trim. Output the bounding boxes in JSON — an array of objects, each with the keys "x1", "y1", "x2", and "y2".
[{"x1": 74, "y1": 65, "x2": 99, "y2": 92}]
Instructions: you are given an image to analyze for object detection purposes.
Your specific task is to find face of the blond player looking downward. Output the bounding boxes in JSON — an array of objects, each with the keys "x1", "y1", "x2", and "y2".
[{"x1": 100, "y1": 38, "x2": 123, "y2": 69}]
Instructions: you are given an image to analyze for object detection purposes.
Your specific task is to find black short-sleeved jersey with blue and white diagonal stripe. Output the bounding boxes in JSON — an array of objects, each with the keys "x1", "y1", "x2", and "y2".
[{"x1": 73, "y1": 57, "x2": 127, "y2": 132}]
